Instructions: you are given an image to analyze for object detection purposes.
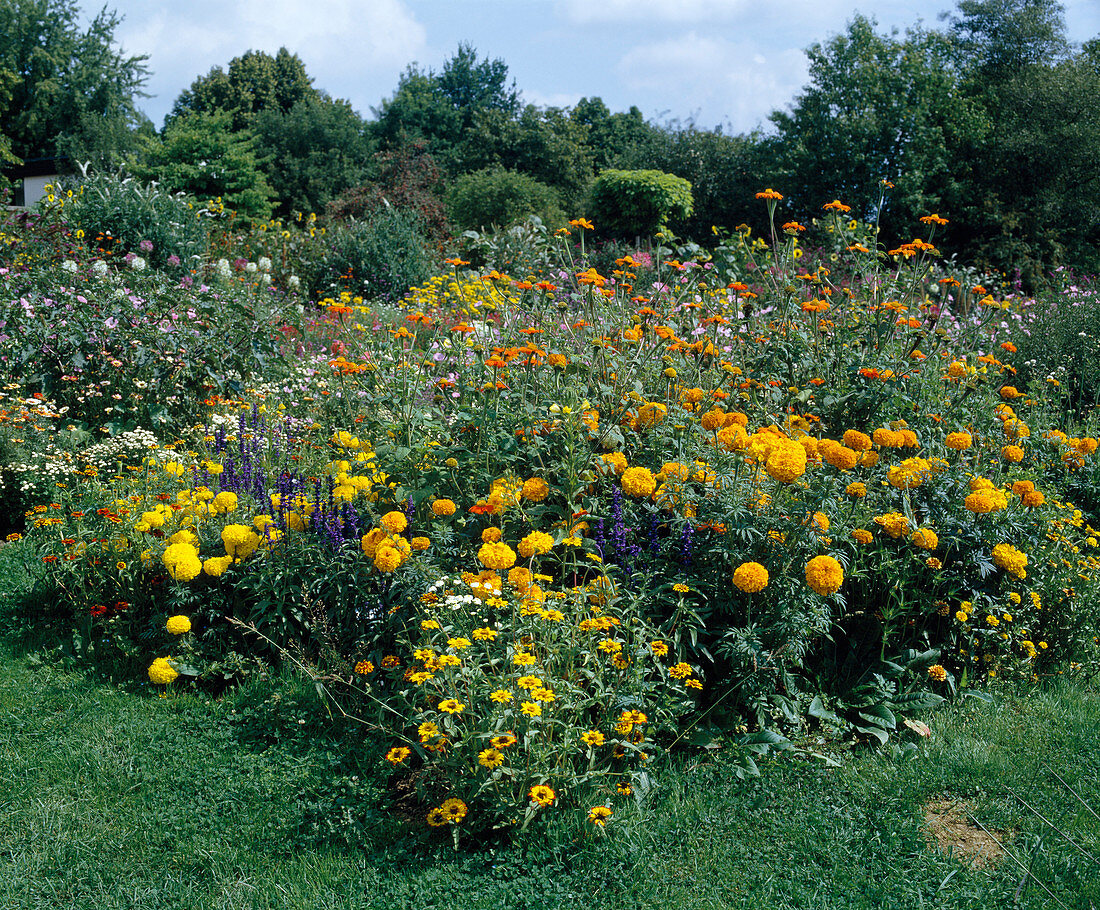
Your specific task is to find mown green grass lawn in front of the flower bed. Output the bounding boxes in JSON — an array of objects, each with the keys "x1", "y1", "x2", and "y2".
[{"x1": 0, "y1": 534, "x2": 1100, "y2": 910}]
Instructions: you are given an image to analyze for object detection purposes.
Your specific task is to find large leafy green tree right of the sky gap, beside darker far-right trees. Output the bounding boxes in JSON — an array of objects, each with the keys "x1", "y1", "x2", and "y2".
[{"x1": 766, "y1": 17, "x2": 990, "y2": 234}]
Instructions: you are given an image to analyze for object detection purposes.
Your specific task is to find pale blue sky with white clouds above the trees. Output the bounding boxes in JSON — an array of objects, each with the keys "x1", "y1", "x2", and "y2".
[{"x1": 103, "y1": 0, "x2": 1100, "y2": 132}]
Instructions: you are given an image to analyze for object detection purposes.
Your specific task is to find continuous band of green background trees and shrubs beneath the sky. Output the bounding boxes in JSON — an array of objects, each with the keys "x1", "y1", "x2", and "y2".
[{"x1": 0, "y1": 0, "x2": 1100, "y2": 278}]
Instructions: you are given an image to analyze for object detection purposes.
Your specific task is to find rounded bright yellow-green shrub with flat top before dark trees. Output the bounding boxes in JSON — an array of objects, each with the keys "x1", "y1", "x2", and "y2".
[{"x1": 591, "y1": 169, "x2": 694, "y2": 237}]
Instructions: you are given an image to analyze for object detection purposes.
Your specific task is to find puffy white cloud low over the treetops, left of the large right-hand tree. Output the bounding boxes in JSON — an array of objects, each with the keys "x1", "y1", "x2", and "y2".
[{"x1": 617, "y1": 31, "x2": 807, "y2": 132}]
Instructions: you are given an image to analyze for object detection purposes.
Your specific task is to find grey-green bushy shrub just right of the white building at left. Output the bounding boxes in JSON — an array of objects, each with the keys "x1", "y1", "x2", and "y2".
[{"x1": 65, "y1": 174, "x2": 210, "y2": 267}]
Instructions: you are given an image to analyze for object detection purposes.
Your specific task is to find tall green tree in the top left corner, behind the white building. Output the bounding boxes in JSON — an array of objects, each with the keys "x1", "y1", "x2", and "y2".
[{"x1": 0, "y1": 0, "x2": 147, "y2": 164}]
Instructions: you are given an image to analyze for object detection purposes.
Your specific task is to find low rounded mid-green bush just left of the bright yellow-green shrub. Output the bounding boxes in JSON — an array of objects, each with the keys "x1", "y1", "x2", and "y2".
[{"x1": 448, "y1": 167, "x2": 565, "y2": 230}]
